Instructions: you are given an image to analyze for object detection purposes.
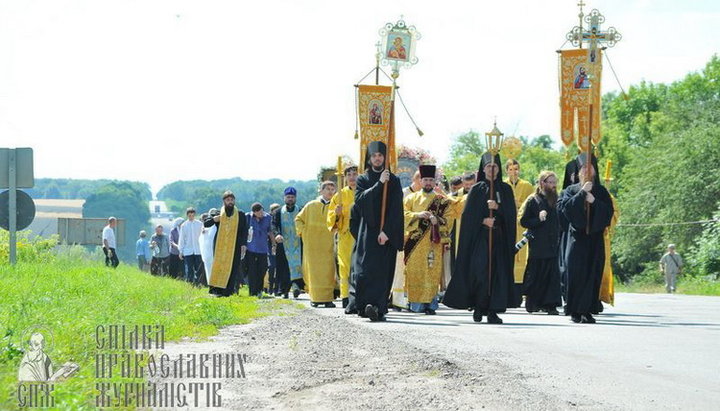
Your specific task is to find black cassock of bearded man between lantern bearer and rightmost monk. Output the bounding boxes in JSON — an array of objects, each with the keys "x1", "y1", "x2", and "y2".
[{"x1": 520, "y1": 194, "x2": 562, "y2": 312}]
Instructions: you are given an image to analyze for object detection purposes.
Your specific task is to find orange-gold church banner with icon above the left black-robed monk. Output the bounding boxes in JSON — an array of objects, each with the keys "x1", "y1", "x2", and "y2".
[{"x1": 358, "y1": 84, "x2": 397, "y2": 173}]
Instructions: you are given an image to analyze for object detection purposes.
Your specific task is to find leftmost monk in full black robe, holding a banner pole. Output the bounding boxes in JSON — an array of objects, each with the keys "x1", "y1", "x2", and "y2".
[{"x1": 352, "y1": 141, "x2": 404, "y2": 321}]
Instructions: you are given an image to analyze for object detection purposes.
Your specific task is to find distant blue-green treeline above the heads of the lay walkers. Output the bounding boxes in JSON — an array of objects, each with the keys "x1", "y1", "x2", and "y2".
[{"x1": 162, "y1": 178, "x2": 319, "y2": 215}]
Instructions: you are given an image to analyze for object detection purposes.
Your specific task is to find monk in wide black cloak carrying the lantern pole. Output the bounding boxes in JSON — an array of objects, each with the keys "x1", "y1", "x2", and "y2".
[{"x1": 443, "y1": 153, "x2": 517, "y2": 324}]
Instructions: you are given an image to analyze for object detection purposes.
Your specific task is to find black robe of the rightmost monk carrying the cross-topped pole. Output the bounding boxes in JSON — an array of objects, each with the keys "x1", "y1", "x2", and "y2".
[{"x1": 558, "y1": 183, "x2": 613, "y2": 314}]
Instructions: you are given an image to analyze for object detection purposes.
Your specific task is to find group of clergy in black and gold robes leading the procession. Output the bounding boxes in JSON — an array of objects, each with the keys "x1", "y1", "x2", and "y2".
[{"x1": 205, "y1": 141, "x2": 616, "y2": 324}]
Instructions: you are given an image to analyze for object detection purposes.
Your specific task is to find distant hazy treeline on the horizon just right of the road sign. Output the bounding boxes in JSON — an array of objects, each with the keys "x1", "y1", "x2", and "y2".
[{"x1": 24, "y1": 178, "x2": 152, "y2": 201}]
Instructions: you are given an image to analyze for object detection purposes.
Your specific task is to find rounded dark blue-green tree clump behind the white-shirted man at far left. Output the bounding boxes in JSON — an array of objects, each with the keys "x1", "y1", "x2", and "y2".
[{"x1": 83, "y1": 182, "x2": 150, "y2": 261}]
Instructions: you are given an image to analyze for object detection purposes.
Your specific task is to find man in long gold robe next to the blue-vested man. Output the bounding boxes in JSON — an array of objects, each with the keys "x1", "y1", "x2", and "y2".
[{"x1": 295, "y1": 181, "x2": 335, "y2": 308}]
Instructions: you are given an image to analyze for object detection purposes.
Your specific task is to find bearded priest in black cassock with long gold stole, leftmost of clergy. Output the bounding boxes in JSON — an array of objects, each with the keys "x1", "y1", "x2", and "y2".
[{"x1": 203, "y1": 191, "x2": 248, "y2": 297}]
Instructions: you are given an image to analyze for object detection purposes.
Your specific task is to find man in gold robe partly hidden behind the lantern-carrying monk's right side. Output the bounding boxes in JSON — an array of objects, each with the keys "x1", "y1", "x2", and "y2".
[{"x1": 505, "y1": 158, "x2": 535, "y2": 308}]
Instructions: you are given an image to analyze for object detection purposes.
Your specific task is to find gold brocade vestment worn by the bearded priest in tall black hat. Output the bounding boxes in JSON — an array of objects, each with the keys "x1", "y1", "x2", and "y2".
[{"x1": 404, "y1": 191, "x2": 465, "y2": 303}]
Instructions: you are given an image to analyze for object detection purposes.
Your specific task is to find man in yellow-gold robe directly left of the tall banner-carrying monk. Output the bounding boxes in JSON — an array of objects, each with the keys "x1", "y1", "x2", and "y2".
[{"x1": 327, "y1": 166, "x2": 358, "y2": 308}]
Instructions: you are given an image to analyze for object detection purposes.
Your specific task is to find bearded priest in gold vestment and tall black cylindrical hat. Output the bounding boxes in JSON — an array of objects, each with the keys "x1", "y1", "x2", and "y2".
[{"x1": 404, "y1": 165, "x2": 465, "y2": 315}]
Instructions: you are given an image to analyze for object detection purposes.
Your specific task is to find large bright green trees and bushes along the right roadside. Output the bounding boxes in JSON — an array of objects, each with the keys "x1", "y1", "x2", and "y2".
[{"x1": 605, "y1": 57, "x2": 720, "y2": 276}]
